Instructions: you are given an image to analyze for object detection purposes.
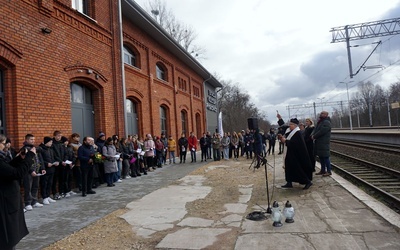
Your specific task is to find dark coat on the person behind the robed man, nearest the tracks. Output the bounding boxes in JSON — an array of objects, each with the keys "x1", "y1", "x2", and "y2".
[{"x1": 311, "y1": 117, "x2": 331, "y2": 157}]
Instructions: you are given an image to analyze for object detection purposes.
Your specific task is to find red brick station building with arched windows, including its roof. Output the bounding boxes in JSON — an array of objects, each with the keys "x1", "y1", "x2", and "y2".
[{"x1": 0, "y1": 0, "x2": 221, "y2": 145}]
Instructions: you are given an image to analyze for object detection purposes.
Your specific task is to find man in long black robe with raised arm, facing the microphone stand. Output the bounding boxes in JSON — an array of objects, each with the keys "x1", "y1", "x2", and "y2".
[{"x1": 278, "y1": 116, "x2": 313, "y2": 189}]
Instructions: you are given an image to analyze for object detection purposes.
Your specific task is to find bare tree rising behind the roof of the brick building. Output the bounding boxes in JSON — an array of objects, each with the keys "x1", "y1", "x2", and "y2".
[{"x1": 145, "y1": 0, "x2": 206, "y2": 59}]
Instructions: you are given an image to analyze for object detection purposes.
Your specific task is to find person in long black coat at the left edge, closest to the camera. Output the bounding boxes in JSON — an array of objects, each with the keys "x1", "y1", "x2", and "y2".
[{"x1": 0, "y1": 135, "x2": 36, "y2": 250}]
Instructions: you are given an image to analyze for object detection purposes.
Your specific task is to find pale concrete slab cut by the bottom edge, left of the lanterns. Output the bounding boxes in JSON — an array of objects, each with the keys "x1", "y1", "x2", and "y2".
[{"x1": 156, "y1": 228, "x2": 231, "y2": 249}]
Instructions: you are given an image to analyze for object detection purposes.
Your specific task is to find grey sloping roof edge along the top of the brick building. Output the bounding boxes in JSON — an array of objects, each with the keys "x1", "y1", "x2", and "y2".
[{"x1": 121, "y1": 0, "x2": 222, "y2": 88}]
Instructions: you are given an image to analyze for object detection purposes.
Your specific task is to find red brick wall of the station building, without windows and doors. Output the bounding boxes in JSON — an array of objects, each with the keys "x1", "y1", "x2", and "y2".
[{"x1": 0, "y1": 0, "x2": 206, "y2": 146}]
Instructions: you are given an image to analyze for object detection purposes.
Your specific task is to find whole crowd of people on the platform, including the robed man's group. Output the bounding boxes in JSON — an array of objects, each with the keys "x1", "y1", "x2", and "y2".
[{"x1": 0, "y1": 111, "x2": 331, "y2": 249}]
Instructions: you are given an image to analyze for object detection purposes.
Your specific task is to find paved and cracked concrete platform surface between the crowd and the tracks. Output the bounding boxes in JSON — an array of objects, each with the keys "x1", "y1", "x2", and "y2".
[{"x1": 17, "y1": 153, "x2": 400, "y2": 250}]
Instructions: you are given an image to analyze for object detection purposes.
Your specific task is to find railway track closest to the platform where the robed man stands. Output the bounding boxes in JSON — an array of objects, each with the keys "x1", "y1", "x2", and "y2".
[{"x1": 331, "y1": 151, "x2": 400, "y2": 213}]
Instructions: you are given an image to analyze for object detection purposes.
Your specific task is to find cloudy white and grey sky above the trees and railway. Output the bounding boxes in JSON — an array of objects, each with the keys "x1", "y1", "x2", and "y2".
[{"x1": 136, "y1": 0, "x2": 400, "y2": 123}]
